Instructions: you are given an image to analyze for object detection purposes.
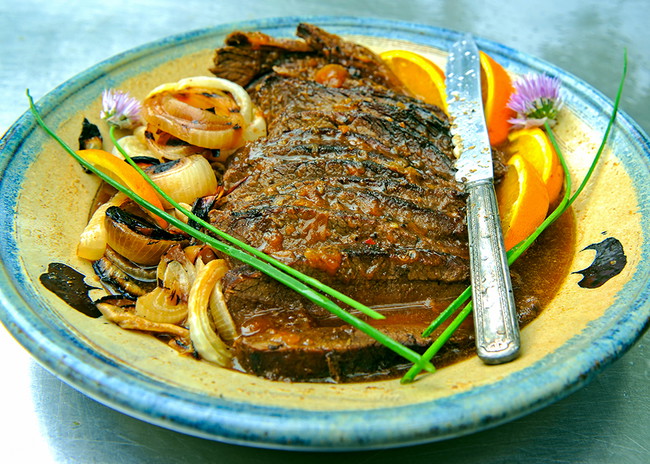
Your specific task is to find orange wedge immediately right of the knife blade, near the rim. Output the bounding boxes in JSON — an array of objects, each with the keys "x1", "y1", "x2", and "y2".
[{"x1": 480, "y1": 52, "x2": 515, "y2": 146}]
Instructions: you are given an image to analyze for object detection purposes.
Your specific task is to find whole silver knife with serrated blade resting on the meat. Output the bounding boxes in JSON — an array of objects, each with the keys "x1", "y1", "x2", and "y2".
[{"x1": 446, "y1": 34, "x2": 520, "y2": 364}]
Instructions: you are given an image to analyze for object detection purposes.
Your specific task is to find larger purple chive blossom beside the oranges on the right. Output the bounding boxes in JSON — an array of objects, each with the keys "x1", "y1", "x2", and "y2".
[{"x1": 508, "y1": 74, "x2": 562, "y2": 128}]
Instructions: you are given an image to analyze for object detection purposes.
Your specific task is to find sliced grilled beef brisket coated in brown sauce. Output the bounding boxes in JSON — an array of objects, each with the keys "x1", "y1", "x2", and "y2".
[{"x1": 205, "y1": 24, "x2": 508, "y2": 381}]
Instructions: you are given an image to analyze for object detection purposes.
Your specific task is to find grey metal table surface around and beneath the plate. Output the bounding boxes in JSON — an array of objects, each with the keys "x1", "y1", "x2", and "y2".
[{"x1": 0, "y1": 0, "x2": 650, "y2": 464}]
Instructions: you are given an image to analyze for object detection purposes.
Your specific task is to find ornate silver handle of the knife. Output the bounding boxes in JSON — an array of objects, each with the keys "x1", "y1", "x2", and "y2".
[{"x1": 466, "y1": 179, "x2": 520, "y2": 364}]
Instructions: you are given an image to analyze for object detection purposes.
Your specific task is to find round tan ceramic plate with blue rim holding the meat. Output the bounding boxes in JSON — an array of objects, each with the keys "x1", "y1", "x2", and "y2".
[{"x1": 0, "y1": 18, "x2": 650, "y2": 450}]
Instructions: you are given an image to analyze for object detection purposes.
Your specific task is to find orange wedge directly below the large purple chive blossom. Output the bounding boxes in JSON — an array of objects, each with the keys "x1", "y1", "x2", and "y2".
[{"x1": 504, "y1": 127, "x2": 564, "y2": 205}]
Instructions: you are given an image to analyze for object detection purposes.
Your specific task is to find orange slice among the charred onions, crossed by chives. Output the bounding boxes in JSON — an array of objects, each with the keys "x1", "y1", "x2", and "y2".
[{"x1": 77, "y1": 149, "x2": 167, "y2": 228}]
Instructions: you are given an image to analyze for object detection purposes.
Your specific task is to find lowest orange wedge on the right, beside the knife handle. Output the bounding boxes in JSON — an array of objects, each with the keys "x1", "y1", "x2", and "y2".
[{"x1": 496, "y1": 155, "x2": 549, "y2": 250}]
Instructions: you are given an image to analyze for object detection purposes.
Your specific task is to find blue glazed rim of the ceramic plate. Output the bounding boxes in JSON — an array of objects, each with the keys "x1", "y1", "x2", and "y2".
[{"x1": 0, "y1": 17, "x2": 650, "y2": 450}]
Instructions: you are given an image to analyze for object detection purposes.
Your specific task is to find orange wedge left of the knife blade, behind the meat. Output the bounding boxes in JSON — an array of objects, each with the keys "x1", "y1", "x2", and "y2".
[{"x1": 379, "y1": 50, "x2": 447, "y2": 112}]
